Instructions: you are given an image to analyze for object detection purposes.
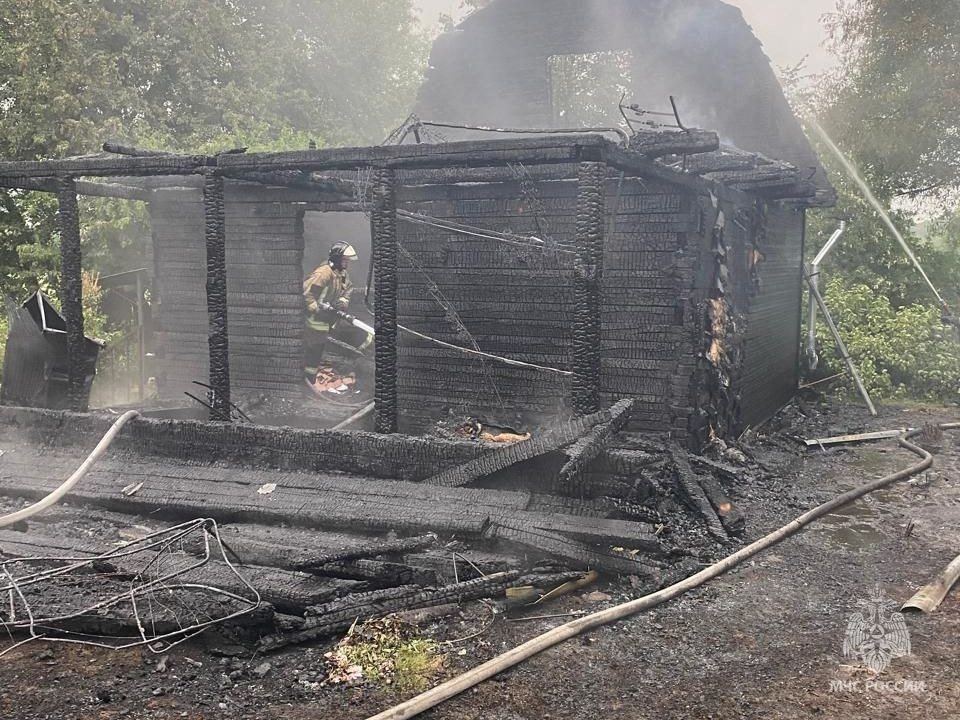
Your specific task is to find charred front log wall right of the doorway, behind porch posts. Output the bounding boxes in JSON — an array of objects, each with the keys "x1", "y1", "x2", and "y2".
[{"x1": 390, "y1": 166, "x2": 698, "y2": 432}]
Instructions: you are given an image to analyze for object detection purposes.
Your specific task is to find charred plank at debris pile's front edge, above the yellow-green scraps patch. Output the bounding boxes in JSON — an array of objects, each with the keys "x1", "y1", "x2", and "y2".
[{"x1": 259, "y1": 571, "x2": 520, "y2": 652}]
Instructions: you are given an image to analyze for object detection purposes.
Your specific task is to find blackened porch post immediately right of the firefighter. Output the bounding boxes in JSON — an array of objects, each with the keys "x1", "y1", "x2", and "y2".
[{"x1": 373, "y1": 168, "x2": 398, "y2": 433}]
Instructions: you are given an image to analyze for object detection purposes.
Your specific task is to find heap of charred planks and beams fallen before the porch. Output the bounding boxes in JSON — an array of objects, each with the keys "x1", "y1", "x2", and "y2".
[{"x1": 0, "y1": 401, "x2": 764, "y2": 650}]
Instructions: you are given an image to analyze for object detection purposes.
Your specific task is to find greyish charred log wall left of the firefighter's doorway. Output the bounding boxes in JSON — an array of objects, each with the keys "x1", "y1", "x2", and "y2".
[{"x1": 151, "y1": 183, "x2": 303, "y2": 398}]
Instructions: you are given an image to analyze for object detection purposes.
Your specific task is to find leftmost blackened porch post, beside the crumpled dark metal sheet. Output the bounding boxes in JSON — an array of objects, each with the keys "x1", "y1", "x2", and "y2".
[{"x1": 57, "y1": 177, "x2": 88, "y2": 411}]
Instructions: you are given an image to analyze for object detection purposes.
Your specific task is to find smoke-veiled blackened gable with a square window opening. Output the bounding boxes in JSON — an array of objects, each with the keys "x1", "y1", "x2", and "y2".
[{"x1": 415, "y1": 0, "x2": 834, "y2": 204}]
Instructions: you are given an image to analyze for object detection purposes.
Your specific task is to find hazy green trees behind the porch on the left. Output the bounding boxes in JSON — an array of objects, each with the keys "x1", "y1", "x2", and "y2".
[{"x1": 0, "y1": 0, "x2": 427, "y2": 380}]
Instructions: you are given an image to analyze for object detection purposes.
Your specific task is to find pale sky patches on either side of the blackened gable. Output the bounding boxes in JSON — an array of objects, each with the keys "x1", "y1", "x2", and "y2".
[{"x1": 414, "y1": 0, "x2": 836, "y2": 73}]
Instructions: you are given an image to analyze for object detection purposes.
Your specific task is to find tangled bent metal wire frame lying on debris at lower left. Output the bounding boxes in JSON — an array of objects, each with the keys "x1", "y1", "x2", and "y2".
[{"x1": 0, "y1": 518, "x2": 261, "y2": 656}]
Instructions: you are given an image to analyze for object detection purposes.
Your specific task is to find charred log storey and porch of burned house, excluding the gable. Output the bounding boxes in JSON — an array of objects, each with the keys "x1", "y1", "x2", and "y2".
[{"x1": 0, "y1": 130, "x2": 817, "y2": 442}]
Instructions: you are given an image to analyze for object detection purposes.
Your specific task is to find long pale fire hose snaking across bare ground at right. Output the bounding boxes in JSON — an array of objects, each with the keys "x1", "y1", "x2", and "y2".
[{"x1": 368, "y1": 423, "x2": 960, "y2": 720}]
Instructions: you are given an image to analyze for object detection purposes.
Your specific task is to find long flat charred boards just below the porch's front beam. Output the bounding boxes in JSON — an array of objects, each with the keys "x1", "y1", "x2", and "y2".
[{"x1": 0, "y1": 446, "x2": 662, "y2": 578}]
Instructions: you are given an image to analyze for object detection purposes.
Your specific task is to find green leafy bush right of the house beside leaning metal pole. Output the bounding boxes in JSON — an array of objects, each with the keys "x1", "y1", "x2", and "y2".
[{"x1": 817, "y1": 278, "x2": 960, "y2": 401}]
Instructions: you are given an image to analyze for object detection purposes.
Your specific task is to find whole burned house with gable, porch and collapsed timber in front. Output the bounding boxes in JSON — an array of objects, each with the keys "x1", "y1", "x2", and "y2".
[{"x1": 0, "y1": 0, "x2": 831, "y2": 650}]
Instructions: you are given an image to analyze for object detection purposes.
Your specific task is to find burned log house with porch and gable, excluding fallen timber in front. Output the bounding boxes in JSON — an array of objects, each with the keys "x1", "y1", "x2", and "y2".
[{"x1": 0, "y1": 0, "x2": 832, "y2": 447}]
